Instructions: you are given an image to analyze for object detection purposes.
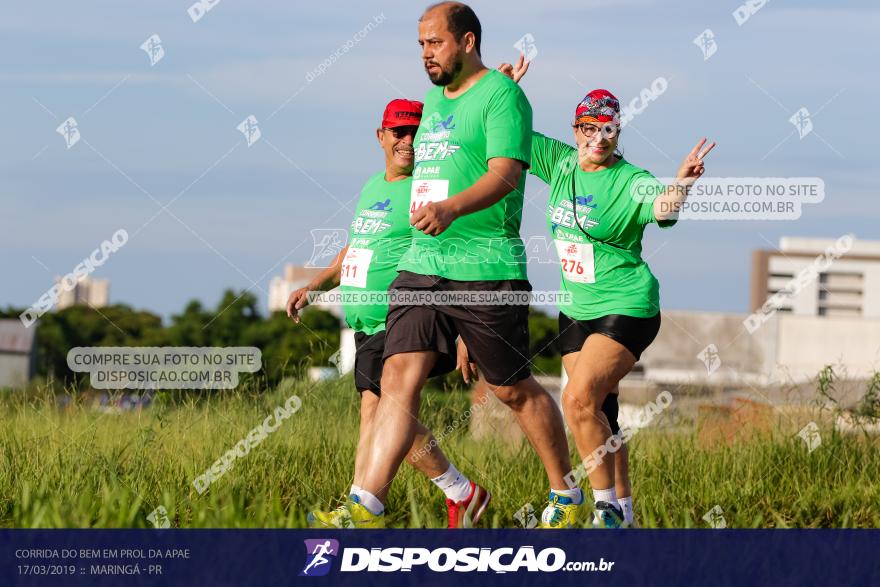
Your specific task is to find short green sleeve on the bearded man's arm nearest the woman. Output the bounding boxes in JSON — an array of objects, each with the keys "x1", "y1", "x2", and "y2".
[{"x1": 486, "y1": 78, "x2": 532, "y2": 167}]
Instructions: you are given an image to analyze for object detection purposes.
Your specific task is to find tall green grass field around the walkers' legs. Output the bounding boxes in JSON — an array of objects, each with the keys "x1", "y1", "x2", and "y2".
[{"x1": 0, "y1": 379, "x2": 880, "y2": 528}]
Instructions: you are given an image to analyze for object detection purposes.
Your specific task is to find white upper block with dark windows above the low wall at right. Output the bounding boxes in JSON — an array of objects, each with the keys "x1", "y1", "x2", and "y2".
[{"x1": 750, "y1": 237, "x2": 880, "y2": 318}]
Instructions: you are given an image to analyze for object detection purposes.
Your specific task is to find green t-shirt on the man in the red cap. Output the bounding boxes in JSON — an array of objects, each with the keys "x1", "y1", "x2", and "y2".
[{"x1": 340, "y1": 171, "x2": 412, "y2": 334}]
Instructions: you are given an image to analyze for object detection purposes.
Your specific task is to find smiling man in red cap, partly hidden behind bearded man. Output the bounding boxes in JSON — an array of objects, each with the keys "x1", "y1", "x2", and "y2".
[{"x1": 287, "y1": 99, "x2": 490, "y2": 528}]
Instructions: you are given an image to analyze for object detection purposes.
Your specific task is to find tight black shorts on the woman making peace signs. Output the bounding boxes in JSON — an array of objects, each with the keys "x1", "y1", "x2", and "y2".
[{"x1": 558, "y1": 312, "x2": 660, "y2": 361}]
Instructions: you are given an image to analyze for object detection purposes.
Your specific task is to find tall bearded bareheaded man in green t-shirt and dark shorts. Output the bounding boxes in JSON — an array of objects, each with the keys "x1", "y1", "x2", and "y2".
[{"x1": 352, "y1": 2, "x2": 582, "y2": 523}]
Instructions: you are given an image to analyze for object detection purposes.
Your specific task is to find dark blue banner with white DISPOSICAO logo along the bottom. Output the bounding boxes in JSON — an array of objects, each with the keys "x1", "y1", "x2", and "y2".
[{"x1": 0, "y1": 529, "x2": 880, "y2": 587}]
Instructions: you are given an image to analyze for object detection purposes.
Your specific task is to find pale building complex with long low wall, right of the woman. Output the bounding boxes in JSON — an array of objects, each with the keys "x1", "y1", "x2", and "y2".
[{"x1": 621, "y1": 237, "x2": 880, "y2": 393}]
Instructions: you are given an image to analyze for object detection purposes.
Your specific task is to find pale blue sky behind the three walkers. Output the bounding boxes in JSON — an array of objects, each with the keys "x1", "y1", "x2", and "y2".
[{"x1": 0, "y1": 0, "x2": 880, "y2": 316}]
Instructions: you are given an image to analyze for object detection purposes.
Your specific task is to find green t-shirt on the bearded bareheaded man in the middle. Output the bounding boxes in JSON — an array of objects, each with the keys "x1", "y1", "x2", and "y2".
[{"x1": 399, "y1": 70, "x2": 532, "y2": 281}]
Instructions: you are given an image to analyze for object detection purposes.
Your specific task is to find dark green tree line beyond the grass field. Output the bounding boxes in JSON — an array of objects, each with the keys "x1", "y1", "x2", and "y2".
[{"x1": 0, "y1": 290, "x2": 560, "y2": 385}]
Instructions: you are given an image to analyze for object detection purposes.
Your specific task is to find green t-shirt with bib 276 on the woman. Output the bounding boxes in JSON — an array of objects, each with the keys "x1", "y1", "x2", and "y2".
[{"x1": 531, "y1": 133, "x2": 675, "y2": 320}]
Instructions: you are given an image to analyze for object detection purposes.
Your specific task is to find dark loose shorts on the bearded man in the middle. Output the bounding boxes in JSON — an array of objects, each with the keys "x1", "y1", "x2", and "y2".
[{"x1": 385, "y1": 271, "x2": 532, "y2": 385}]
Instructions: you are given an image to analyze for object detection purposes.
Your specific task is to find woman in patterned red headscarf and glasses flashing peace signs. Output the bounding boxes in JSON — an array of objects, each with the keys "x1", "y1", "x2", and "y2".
[{"x1": 499, "y1": 58, "x2": 715, "y2": 528}]
